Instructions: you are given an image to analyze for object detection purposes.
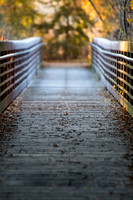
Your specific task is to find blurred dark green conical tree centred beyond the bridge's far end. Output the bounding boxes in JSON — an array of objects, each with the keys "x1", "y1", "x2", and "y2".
[{"x1": 37, "y1": 0, "x2": 94, "y2": 58}]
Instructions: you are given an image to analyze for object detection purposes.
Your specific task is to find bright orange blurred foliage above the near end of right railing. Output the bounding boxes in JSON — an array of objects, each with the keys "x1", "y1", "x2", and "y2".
[{"x1": 82, "y1": 0, "x2": 118, "y2": 40}]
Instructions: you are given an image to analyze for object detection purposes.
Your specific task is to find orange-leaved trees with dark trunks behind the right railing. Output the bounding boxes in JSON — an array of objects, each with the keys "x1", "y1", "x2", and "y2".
[{"x1": 88, "y1": 0, "x2": 133, "y2": 41}]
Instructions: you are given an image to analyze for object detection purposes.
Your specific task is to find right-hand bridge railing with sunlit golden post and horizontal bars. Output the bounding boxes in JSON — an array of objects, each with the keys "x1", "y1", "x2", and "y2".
[{"x1": 91, "y1": 38, "x2": 133, "y2": 117}]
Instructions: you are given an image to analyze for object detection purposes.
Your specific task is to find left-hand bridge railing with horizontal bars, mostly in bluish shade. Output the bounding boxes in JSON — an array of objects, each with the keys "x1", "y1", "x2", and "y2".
[{"x1": 0, "y1": 37, "x2": 43, "y2": 112}]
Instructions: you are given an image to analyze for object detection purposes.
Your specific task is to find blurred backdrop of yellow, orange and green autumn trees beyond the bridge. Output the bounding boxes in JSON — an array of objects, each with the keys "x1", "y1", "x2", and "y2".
[{"x1": 0, "y1": 0, "x2": 132, "y2": 60}]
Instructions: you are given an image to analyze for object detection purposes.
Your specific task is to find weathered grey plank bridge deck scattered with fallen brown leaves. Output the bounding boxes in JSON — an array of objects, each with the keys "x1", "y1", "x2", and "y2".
[{"x1": 0, "y1": 66, "x2": 133, "y2": 200}]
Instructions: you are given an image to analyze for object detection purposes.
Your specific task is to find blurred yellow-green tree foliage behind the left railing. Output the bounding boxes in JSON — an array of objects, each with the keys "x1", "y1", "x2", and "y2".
[{"x1": 0, "y1": 0, "x2": 37, "y2": 39}]
